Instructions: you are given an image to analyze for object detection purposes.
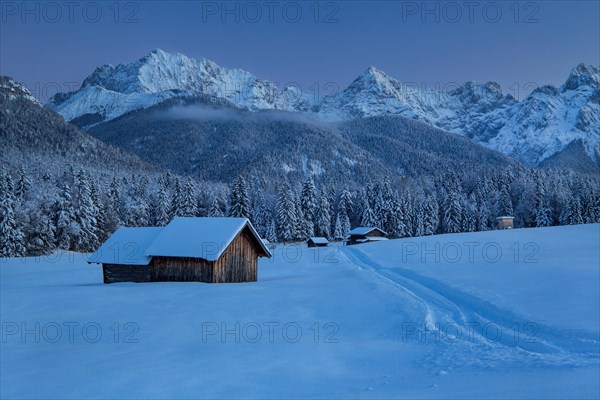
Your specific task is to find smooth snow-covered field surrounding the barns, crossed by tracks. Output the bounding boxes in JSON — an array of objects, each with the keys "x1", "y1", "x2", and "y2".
[{"x1": 0, "y1": 224, "x2": 600, "y2": 399}]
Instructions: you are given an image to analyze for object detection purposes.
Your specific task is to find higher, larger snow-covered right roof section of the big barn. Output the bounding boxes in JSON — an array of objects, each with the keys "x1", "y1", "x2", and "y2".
[{"x1": 146, "y1": 217, "x2": 271, "y2": 261}]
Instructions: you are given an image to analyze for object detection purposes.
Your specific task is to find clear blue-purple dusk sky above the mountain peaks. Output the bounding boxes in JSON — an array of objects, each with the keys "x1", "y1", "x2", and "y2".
[{"x1": 0, "y1": 1, "x2": 600, "y2": 101}]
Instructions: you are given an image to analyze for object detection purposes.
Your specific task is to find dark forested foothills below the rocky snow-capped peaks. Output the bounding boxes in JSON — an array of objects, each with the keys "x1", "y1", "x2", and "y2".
[{"x1": 0, "y1": 77, "x2": 517, "y2": 187}]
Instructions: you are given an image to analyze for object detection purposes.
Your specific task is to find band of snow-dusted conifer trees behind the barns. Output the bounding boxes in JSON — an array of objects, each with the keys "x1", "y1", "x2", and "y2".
[{"x1": 0, "y1": 164, "x2": 600, "y2": 257}]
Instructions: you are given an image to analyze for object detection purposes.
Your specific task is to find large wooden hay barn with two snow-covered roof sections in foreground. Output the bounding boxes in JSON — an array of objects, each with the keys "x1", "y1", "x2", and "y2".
[{"x1": 88, "y1": 218, "x2": 271, "y2": 283}]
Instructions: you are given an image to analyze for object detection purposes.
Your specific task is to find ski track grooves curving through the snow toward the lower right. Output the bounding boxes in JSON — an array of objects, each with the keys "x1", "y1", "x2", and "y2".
[{"x1": 342, "y1": 248, "x2": 600, "y2": 369}]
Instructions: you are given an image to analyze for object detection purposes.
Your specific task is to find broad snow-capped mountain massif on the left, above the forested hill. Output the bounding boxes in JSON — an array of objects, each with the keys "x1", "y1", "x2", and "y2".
[{"x1": 47, "y1": 49, "x2": 312, "y2": 123}]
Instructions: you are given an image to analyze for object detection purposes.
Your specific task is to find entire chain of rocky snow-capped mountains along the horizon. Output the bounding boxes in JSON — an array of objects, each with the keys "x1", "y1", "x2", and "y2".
[{"x1": 46, "y1": 50, "x2": 600, "y2": 168}]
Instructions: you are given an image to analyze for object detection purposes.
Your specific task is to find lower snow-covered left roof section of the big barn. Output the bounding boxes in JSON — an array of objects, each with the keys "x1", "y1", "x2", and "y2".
[{"x1": 87, "y1": 227, "x2": 164, "y2": 265}]
